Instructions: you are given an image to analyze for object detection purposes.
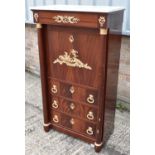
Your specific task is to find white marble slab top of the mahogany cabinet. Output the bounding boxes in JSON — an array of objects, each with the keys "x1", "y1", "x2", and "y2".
[{"x1": 30, "y1": 5, "x2": 125, "y2": 13}]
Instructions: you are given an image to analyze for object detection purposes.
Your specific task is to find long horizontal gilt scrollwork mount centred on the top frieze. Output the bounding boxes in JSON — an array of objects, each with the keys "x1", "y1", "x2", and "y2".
[{"x1": 53, "y1": 15, "x2": 80, "y2": 24}]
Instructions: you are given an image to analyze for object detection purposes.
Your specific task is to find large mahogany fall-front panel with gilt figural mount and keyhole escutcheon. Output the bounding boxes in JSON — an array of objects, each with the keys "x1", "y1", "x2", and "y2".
[{"x1": 44, "y1": 25, "x2": 106, "y2": 88}]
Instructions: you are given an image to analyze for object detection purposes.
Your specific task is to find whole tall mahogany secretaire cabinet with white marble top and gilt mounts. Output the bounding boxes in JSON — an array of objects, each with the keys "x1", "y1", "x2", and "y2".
[{"x1": 31, "y1": 5, "x2": 124, "y2": 152}]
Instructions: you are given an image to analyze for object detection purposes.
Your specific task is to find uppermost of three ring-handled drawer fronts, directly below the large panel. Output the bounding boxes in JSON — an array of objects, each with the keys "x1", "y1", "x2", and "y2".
[{"x1": 49, "y1": 79, "x2": 98, "y2": 105}]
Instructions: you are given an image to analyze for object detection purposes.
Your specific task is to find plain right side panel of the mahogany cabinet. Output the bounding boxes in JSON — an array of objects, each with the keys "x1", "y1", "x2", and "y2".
[{"x1": 103, "y1": 11, "x2": 123, "y2": 142}]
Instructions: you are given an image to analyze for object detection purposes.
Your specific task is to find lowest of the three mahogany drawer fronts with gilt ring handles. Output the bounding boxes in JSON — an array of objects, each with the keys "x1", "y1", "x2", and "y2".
[{"x1": 51, "y1": 111, "x2": 96, "y2": 137}]
